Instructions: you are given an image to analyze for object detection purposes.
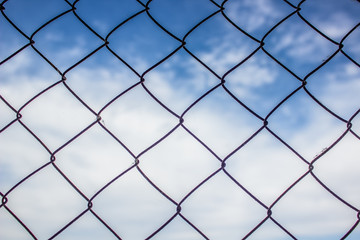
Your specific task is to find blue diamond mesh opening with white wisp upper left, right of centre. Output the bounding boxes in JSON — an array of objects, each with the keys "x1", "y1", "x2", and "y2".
[{"x1": 225, "y1": 51, "x2": 300, "y2": 117}]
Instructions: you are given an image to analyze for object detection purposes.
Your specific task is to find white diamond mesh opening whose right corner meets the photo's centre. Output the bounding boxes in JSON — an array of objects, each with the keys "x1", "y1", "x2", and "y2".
[{"x1": 101, "y1": 86, "x2": 178, "y2": 153}]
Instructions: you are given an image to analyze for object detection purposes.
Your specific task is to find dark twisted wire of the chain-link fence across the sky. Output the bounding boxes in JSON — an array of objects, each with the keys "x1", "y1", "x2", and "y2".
[{"x1": 0, "y1": 0, "x2": 360, "y2": 239}]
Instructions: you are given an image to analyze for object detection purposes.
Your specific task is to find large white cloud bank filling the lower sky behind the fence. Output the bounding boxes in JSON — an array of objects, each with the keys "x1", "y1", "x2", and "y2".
[{"x1": 0, "y1": 8, "x2": 359, "y2": 239}]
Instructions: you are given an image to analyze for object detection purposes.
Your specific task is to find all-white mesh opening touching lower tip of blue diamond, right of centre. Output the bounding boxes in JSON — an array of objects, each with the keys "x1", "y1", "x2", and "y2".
[{"x1": 226, "y1": 131, "x2": 307, "y2": 206}]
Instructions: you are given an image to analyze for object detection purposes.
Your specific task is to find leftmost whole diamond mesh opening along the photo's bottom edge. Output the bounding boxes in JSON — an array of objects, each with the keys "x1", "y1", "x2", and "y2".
[{"x1": 6, "y1": 165, "x2": 86, "y2": 238}]
